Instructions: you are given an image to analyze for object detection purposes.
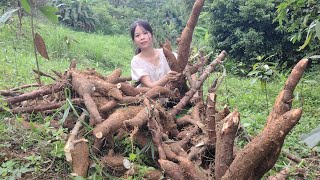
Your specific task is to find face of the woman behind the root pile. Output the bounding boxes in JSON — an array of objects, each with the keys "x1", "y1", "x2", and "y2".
[{"x1": 134, "y1": 25, "x2": 153, "y2": 49}]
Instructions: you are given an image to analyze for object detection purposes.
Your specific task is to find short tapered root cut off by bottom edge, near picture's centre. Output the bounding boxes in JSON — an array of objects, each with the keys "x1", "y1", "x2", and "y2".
[{"x1": 158, "y1": 159, "x2": 185, "y2": 180}]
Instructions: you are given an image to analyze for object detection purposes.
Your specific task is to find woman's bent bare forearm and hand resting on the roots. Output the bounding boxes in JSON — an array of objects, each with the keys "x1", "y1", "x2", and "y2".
[{"x1": 140, "y1": 71, "x2": 180, "y2": 88}]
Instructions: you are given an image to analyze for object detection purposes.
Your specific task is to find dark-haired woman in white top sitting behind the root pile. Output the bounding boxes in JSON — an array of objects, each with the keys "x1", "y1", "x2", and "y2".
[{"x1": 130, "y1": 20, "x2": 180, "y2": 87}]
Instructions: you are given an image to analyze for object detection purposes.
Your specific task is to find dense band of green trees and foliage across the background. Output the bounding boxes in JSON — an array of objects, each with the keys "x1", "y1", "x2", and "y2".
[{"x1": 0, "y1": 0, "x2": 320, "y2": 70}]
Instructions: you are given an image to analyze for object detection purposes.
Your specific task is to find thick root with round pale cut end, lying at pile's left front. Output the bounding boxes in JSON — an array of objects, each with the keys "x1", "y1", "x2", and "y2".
[{"x1": 93, "y1": 106, "x2": 143, "y2": 139}]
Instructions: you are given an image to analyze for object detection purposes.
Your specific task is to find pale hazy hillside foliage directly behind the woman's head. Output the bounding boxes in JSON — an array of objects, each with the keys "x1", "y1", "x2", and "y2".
[{"x1": 100, "y1": 0, "x2": 193, "y2": 43}]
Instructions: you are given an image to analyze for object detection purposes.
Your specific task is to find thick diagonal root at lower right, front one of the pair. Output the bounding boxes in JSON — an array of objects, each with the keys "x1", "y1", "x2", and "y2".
[{"x1": 222, "y1": 109, "x2": 302, "y2": 179}]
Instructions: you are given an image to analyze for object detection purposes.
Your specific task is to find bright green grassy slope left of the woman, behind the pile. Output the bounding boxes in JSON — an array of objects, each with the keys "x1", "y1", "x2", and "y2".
[{"x1": 0, "y1": 18, "x2": 133, "y2": 89}]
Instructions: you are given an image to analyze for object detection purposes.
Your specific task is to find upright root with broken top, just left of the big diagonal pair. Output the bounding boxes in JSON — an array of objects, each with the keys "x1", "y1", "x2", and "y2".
[{"x1": 214, "y1": 111, "x2": 240, "y2": 179}]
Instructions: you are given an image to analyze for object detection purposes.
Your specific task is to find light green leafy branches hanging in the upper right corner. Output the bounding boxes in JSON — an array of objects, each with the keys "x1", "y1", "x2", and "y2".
[{"x1": 275, "y1": 0, "x2": 320, "y2": 52}]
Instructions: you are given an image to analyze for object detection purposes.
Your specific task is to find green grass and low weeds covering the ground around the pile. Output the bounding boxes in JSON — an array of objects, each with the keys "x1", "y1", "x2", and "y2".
[{"x1": 0, "y1": 0, "x2": 320, "y2": 179}]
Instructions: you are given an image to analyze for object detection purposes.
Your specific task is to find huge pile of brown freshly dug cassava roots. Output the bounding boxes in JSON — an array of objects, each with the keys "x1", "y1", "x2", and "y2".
[{"x1": 0, "y1": 0, "x2": 308, "y2": 180}]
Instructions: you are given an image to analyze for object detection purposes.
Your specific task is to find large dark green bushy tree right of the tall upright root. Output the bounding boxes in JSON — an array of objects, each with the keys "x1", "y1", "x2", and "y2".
[{"x1": 209, "y1": 0, "x2": 300, "y2": 68}]
